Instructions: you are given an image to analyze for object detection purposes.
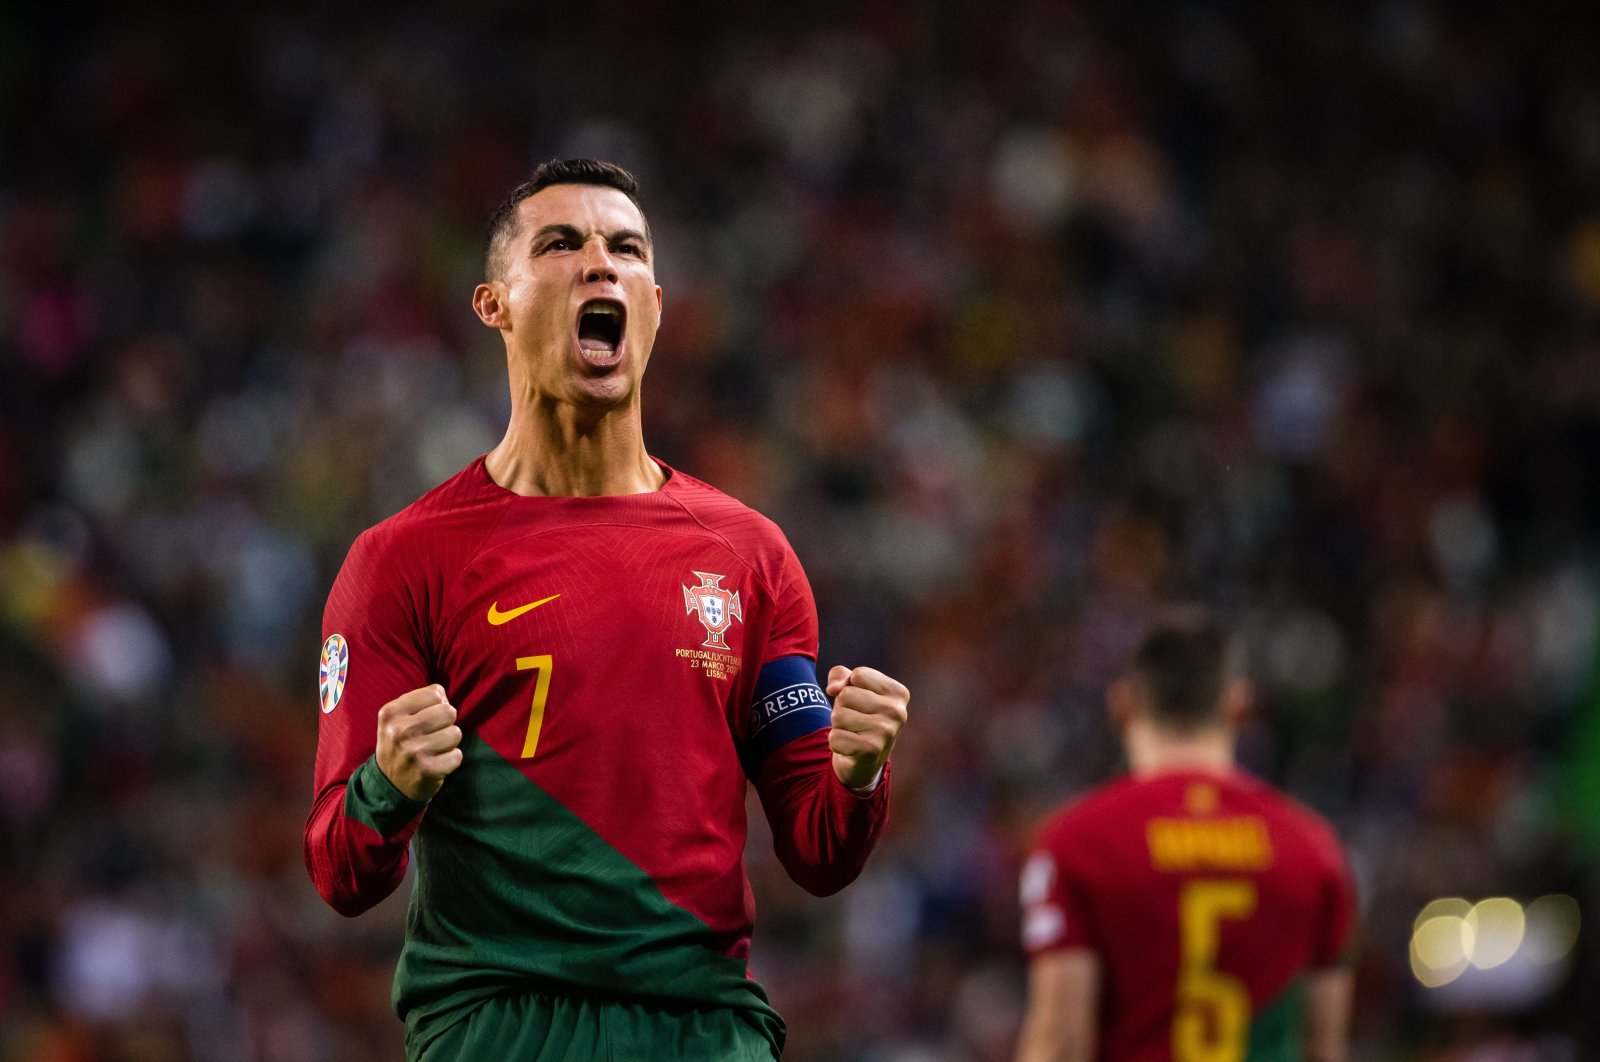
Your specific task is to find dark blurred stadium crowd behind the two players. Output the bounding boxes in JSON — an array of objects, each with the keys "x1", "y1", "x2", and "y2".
[{"x1": 0, "y1": 0, "x2": 1600, "y2": 1062}]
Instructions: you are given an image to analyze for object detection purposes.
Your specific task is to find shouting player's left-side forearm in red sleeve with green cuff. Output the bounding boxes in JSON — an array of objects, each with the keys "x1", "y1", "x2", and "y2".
[{"x1": 306, "y1": 760, "x2": 426, "y2": 916}]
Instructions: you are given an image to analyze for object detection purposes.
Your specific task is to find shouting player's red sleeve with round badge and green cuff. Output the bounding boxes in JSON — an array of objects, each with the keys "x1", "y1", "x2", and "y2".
[{"x1": 306, "y1": 526, "x2": 430, "y2": 915}]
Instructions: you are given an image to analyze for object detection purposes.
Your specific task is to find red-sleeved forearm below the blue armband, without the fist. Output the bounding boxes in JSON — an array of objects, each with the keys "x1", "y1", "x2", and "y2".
[{"x1": 755, "y1": 731, "x2": 890, "y2": 896}]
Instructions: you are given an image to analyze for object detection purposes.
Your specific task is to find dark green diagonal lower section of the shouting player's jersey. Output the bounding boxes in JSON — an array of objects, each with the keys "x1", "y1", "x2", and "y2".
[{"x1": 394, "y1": 733, "x2": 784, "y2": 1051}]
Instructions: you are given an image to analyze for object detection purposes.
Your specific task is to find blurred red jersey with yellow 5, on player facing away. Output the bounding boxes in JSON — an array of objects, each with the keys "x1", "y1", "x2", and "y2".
[{"x1": 1022, "y1": 771, "x2": 1354, "y2": 1062}]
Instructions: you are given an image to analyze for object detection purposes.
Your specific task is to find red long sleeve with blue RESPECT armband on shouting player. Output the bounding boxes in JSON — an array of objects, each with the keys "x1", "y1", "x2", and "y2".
[{"x1": 742, "y1": 544, "x2": 890, "y2": 896}]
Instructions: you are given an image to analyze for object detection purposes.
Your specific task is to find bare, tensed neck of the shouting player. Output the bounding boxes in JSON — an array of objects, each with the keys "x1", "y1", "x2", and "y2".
[{"x1": 483, "y1": 401, "x2": 667, "y2": 497}]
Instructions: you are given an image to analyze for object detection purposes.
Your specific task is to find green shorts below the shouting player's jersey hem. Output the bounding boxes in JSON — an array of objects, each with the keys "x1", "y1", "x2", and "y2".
[{"x1": 406, "y1": 993, "x2": 778, "y2": 1062}]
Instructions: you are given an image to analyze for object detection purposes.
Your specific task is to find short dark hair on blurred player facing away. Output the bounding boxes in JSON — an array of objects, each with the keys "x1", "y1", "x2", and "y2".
[{"x1": 1130, "y1": 605, "x2": 1235, "y2": 733}]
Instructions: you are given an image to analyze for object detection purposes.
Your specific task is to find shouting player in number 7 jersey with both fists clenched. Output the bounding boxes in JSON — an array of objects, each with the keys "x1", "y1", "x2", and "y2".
[{"x1": 306, "y1": 160, "x2": 909, "y2": 1060}]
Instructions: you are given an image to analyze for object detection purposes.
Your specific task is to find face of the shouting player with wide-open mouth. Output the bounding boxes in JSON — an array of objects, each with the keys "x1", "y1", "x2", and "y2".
[{"x1": 480, "y1": 184, "x2": 661, "y2": 406}]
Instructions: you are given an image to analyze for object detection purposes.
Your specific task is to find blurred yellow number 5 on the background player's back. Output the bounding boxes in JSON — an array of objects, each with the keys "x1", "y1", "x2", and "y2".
[{"x1": 1173, "y1": 881, "x2": 1256, "y2": 1062}]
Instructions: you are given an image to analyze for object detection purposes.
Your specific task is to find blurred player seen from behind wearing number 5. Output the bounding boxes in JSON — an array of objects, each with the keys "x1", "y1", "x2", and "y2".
[{"x1": 1018, "y1": 608, "x2": 1354, "y2": 1062}]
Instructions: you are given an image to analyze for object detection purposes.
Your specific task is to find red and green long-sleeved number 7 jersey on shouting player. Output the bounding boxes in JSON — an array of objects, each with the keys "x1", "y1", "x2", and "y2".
[{"x1": 306, "y1": 459, "x2": 888, "y2": 1051}]
